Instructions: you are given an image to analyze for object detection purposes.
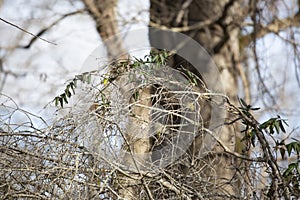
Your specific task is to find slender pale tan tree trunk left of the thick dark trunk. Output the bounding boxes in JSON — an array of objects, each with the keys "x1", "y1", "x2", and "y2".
[{"x1": 83, "y1": 0, "x2": 151, "y2": 199}]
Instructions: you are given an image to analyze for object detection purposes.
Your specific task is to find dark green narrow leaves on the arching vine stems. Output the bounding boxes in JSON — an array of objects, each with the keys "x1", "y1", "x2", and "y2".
[{"x1": 50, "y1": 51, "x2": 300, "y2": 196}]
